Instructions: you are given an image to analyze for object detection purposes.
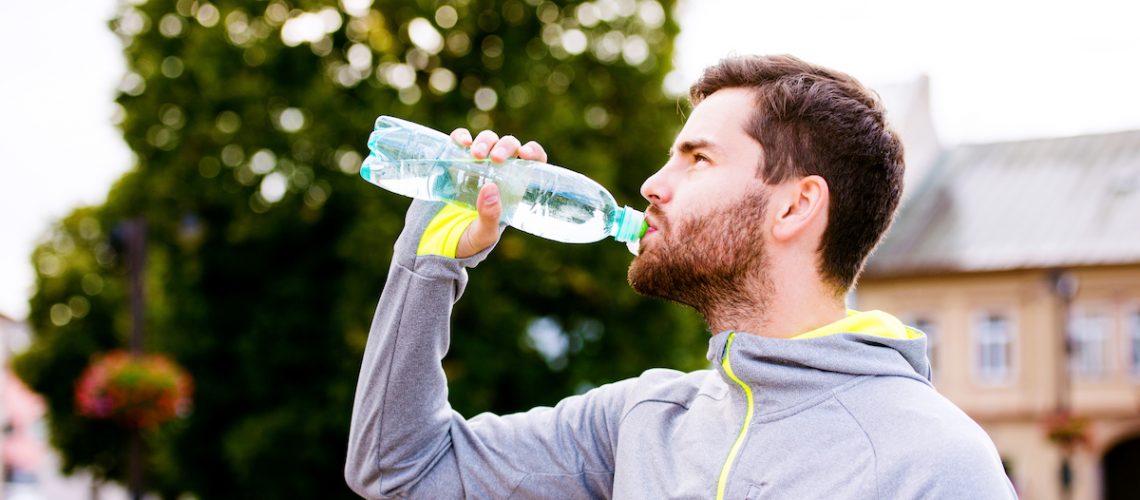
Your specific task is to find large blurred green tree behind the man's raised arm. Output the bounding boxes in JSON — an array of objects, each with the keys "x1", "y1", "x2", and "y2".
[{"x1": 17, "y1": 0, "x2": 707, "y2": 498}]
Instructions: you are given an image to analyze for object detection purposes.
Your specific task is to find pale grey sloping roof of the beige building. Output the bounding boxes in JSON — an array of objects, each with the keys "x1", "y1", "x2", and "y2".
[{"x1": 865, "y1": 130, "x2": 1140, "y2": 278}]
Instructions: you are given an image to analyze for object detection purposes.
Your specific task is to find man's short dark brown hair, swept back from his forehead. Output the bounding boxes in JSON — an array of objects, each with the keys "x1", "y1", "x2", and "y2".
[{"x1": 689, "y1": 56, "x2": 904, "y2": 293}]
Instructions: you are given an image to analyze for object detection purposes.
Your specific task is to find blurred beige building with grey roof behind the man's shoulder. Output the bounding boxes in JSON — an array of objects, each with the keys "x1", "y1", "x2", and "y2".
[{"x1": 854, "y1": 131, "x2": 1140, "y2": 500}]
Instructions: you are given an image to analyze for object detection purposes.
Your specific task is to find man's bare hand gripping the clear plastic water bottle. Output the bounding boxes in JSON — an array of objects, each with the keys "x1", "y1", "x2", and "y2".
[{"x1": 451, "y1": 129, "x2": 546, "y2": 259}]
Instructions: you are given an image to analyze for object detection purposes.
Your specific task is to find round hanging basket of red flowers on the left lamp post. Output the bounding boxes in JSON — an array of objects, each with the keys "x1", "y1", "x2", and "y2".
[{"x1": 75, "y1": 350, "x2": 194, "y2": 429}]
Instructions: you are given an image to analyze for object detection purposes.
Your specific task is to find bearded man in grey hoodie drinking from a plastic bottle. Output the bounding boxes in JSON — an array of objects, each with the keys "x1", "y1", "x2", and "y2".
[{"x1": 345, "y1": 56, "x2": 1016, "y2": 499}]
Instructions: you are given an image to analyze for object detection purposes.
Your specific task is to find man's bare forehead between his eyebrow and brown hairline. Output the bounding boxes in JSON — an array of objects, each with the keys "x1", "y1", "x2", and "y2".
[{"x1": 676, "y1": 89, "x2": 757, "y2": 148}]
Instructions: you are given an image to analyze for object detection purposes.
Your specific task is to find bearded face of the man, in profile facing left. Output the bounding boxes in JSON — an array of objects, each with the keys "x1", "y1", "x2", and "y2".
[{"x1": 628, "y1": 89, "x2": 767, "y2": 312}]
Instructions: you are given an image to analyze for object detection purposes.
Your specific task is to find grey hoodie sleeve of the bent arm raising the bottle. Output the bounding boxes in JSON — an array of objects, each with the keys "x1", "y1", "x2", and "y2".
[{"x1": 344, "y1": 202, "x2": 629, "y2": 498}]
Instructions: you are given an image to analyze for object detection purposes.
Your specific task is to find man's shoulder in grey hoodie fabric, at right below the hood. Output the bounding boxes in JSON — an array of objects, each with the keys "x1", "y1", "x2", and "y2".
[{"x1": 837, "y1": 377, "x2": 1012, "y2": 498}]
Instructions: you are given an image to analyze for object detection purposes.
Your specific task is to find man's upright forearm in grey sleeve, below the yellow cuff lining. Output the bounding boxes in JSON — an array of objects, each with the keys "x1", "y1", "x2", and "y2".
[{"x1": 345, "y1": 253, "x2": 464, "y2": 498}]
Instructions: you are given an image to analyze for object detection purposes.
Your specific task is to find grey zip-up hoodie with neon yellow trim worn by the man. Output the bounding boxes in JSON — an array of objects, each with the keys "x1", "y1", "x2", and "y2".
[{"x1": 345, "y1": 202, "x2": 1016, "y2": 499}]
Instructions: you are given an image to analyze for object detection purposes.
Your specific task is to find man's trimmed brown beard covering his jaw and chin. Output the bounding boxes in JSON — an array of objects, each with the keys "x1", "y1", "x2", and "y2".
[{"x1": 627, "y1": 191, "x2": 771, "y2": 321}]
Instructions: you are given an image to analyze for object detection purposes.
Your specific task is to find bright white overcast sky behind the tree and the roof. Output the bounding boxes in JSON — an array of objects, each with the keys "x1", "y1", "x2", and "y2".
[{"x1": 0, "y1": 0, "x2": 1140, "y2": 319}]
